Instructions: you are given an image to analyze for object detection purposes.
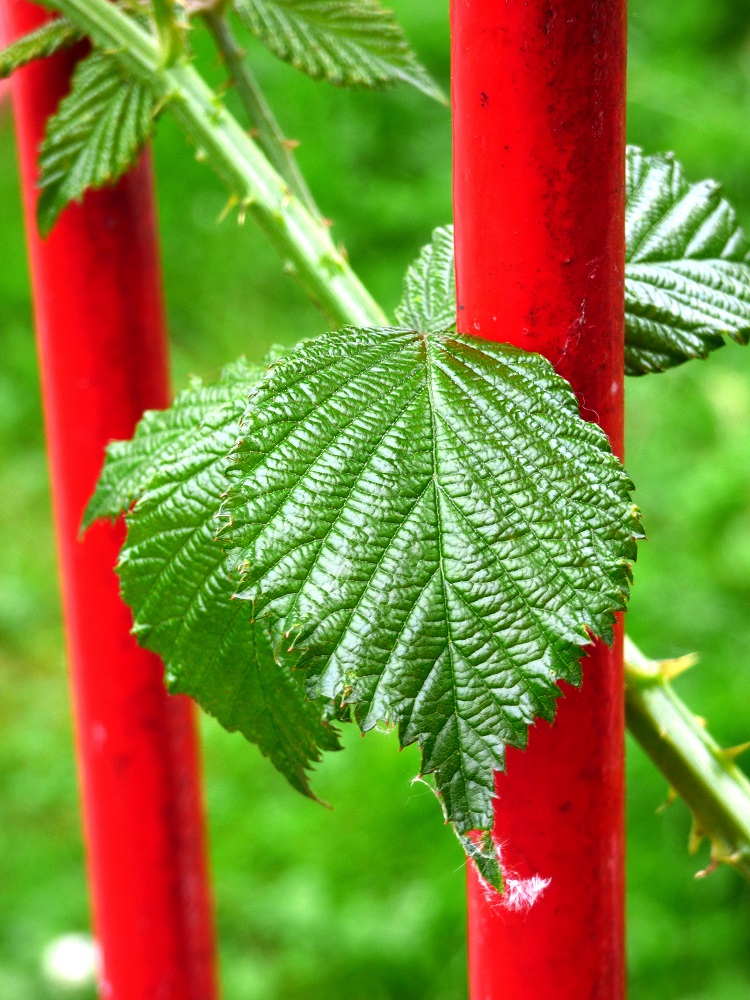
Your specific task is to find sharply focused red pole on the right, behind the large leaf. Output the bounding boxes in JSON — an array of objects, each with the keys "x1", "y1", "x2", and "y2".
[{"x1": 452, "y1": 0, "x2": 626, "y2": 1000}]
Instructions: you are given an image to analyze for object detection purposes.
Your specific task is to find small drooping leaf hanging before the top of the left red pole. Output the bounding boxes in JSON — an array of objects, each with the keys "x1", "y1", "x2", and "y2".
[{"x1": 37, "y1": 52, "x2": 155, "y2": 235}]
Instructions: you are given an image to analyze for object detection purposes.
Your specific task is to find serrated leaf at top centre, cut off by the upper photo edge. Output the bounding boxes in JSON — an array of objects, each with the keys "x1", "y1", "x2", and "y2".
[{"x1": 234, "y1": 0, "x2": 443, "y2": 101}]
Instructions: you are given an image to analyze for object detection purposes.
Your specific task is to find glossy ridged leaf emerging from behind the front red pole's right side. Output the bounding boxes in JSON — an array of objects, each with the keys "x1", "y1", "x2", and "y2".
[{"x1": 625, "y1": 146, "x2": 750, "y2": 375}]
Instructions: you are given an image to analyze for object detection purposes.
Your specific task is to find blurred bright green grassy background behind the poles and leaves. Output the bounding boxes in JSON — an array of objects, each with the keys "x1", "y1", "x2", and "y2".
[{"x1": 0, "y1": 0, "x2": 750, "y2": 1000}]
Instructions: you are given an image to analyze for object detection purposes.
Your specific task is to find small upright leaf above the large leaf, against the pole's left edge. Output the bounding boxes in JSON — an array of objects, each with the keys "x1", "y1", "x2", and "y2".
[{"x1": 396, "y1": 226, "x2": 456, "y2": 333}]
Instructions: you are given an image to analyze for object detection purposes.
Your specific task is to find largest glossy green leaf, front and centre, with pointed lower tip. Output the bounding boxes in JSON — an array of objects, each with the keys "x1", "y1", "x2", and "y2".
[{"x1": 224, "y1": 329, "x2": 640, "y2": 834}]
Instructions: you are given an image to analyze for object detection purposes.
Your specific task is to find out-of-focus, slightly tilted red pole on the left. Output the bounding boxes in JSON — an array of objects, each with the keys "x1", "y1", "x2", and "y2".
[{"x1": 4, "y1": 0, "x2": 216, "y2": 1000}]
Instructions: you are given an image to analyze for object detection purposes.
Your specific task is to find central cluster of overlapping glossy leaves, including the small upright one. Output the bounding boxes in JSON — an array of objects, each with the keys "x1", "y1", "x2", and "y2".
[{"x1": 87, "y1": 234, "x2": 640, "y2": 886}]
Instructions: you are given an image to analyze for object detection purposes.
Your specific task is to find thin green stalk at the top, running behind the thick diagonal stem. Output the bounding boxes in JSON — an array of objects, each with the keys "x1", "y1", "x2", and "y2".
[{"x1": 203, "y1": 10, "x2": 320, "y2": 217}]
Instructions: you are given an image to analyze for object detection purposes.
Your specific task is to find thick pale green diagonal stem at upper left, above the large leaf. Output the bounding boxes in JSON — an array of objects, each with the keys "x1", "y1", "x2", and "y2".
[{"x1": 48, "y1": 0, "x2": 388, "y2": 326}]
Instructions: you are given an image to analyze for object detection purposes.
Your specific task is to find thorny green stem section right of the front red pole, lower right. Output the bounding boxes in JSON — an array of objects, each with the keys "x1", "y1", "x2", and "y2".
[{"x1": 625, "y1": 639, "x2": 750, "y2": 879}]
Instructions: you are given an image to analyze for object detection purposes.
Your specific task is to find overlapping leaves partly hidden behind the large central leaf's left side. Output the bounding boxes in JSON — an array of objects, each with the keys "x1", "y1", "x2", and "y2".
[{"x1": 86, "y1": 362, "x2": 338, "y2": 795}]
